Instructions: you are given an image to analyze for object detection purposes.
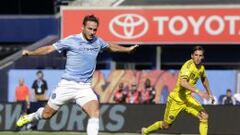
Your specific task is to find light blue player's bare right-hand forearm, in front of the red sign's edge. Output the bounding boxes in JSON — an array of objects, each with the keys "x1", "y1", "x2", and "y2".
[{"x1": 109, "y1": 43, "x2": 139, "y2": 52}]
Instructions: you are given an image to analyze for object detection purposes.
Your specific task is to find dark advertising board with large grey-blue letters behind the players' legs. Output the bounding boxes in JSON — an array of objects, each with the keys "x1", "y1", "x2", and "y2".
[{"x1": 0, "y1": 104, "x2": 240, "y2": 135}]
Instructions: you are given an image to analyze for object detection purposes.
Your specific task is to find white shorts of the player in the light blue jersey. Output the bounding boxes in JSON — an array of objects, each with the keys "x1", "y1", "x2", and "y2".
[{"x1": 48, "y1": 79, "x2": 98, "y2": 110}]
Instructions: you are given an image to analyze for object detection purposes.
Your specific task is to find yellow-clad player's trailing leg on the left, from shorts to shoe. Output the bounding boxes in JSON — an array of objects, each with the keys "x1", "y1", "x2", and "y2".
[{"x1": 142, "y1": 97, "x2": 185, "y2": 135}]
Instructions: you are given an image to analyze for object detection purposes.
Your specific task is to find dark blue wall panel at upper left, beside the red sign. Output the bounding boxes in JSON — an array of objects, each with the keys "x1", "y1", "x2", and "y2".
[{"x1": 0, "y1": 16, "x2": 60, "y2": 43}]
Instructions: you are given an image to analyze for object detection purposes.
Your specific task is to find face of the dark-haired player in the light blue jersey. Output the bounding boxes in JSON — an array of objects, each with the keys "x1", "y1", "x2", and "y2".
[{"x1": 82, "y1": 21, "x2": 98, "y2": 41}]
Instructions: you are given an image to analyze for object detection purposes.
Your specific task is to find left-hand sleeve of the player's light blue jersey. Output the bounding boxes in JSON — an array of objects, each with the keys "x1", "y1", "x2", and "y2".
[{"x1": 53, "y1": 38, "x2": 72, "y2": 53}]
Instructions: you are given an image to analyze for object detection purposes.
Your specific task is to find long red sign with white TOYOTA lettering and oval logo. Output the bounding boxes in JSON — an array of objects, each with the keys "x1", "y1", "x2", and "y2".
[{"x1": 62, "y1": 6, "x2": 240, "y2": 44}]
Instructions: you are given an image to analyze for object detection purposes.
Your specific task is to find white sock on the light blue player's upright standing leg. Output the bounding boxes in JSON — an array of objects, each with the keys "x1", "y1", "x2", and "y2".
[{"x1": 87, "y1": 118, "x2": 99, "y2": 135}]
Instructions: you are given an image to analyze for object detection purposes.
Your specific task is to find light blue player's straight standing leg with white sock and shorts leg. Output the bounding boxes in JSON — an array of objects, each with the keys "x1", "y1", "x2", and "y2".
[{"x1": 76, "y1": 88, "x2": 100, "y2": 135}]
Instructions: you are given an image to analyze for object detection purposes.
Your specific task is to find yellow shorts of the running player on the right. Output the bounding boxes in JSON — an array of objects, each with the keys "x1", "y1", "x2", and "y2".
[{"x1": 163, "y1": 96, "x2": 204, "y2": 124}]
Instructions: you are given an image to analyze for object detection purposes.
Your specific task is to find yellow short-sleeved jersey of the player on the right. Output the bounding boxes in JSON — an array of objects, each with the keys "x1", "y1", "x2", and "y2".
[{"x1": 170, "y1": 59, "x2": 206, "y2": 101}]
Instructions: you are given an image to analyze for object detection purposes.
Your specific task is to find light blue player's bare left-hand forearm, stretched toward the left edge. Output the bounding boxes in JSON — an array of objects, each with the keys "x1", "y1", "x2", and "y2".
[{"x1": 22, "y1": 45, "x2": 56, "y2": 56}]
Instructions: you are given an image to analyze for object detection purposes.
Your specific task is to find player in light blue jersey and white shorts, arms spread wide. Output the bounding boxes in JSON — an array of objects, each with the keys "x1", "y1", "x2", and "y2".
[{"x1": 16, "y1": 15, "x2": 138, "y2": 135}]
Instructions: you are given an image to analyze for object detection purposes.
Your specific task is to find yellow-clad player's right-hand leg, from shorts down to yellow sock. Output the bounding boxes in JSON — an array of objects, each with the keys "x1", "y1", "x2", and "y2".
[{"x1": 186, "y1": 98, "x2": 208, "y2": 135}]
